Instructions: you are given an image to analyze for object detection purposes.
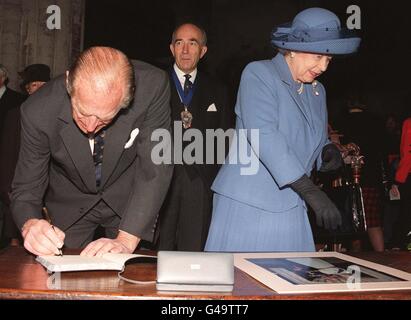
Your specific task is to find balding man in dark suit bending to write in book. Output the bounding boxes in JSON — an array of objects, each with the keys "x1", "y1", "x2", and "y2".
[{"x1": 11, "y1": 47, "x2": 172, "y2": 256}]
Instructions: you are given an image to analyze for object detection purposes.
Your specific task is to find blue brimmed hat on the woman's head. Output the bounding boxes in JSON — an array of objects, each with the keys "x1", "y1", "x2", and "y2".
[{"x1": 271, "y1": 8, "x2": 361, "y2": 55}]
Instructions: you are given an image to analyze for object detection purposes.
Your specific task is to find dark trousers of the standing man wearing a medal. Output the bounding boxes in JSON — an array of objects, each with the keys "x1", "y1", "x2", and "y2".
[{"x1": 158, "y1": 166, "x2": 212, "y2": 251}]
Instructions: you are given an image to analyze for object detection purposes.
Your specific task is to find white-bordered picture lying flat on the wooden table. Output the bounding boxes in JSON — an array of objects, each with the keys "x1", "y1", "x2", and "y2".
[{"x1": 234, "y1": 252, "x2": 411, "y2": 294}]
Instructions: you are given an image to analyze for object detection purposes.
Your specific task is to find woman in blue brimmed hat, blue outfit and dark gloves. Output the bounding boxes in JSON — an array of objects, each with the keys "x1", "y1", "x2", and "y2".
[{"x1": 205, "y1": 8, "x2": 360, "y2": 252}]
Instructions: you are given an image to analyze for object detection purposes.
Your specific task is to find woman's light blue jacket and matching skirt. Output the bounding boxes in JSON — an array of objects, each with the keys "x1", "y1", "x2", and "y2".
[{"x1": 206, "y1": 54, "x2": 328, "y2": 251}]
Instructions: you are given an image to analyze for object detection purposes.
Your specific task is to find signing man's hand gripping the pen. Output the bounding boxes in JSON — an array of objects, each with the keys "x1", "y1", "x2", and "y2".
[{"x1": 22, "y1": 219, "x2": 65, "y2": 256}]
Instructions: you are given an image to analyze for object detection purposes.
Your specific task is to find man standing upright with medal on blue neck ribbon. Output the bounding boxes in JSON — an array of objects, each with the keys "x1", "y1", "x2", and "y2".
[{"x1": 158, "y1": 23, "x2": 231, "y2": 251}]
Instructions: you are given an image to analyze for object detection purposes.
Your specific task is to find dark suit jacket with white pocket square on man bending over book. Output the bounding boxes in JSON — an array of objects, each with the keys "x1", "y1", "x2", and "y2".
[{"x1": 11, "y1": 61, "x2": 172, "y2": 241}]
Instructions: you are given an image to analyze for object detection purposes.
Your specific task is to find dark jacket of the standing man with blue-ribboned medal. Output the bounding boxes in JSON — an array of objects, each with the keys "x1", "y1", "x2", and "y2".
[{"x1": 169, "y1": 69, "x2": 234, "y2": 186}]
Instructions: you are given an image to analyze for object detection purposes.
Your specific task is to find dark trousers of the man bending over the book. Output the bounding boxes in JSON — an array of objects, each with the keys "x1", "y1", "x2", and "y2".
[{"x1": 64, "y1": 200, "x2": 121, "y2": 248}]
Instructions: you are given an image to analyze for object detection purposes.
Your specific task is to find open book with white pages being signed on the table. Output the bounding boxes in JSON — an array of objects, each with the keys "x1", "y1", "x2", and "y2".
[{"x1": 36, "y1": 253, "x2": 155, "y2": 272}]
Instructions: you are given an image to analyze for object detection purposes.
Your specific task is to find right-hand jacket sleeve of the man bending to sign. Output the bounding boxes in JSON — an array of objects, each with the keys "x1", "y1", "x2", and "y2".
[{"x1": 119, "y1": 73, "x2": 173, "y2": 241}]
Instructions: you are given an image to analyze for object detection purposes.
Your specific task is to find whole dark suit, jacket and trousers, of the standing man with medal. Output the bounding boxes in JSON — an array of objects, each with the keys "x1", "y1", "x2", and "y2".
[{"x1": 157, "y1": 69, "x2": 233, "y2": 251}]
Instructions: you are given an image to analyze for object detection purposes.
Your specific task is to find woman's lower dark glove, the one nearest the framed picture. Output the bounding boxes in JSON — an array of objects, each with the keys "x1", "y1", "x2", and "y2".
[{"x1": 291, "y1": 175, "x2": 341, "y2": 230}]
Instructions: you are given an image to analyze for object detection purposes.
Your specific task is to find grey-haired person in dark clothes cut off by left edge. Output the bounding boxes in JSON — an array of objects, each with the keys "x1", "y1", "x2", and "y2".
[{"x1": 0, "y1": 64, "x2": 24, "y2": 244}]
